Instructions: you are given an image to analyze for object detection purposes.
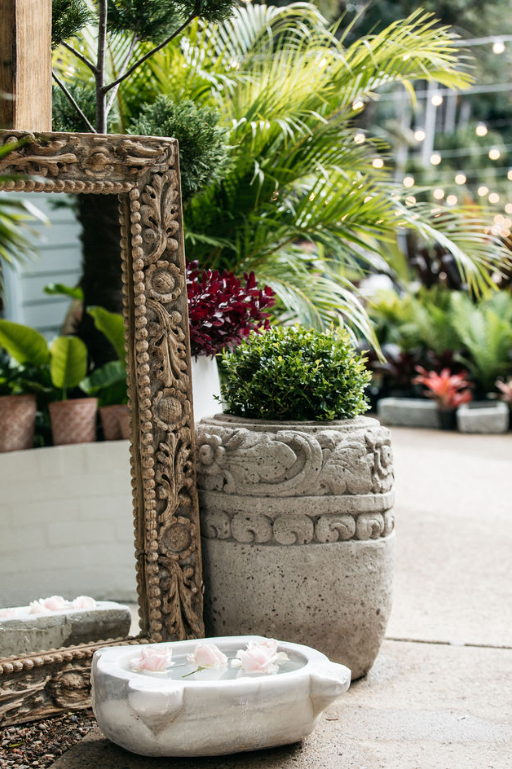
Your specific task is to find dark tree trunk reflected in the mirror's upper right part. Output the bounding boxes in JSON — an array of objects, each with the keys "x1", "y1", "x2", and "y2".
[{"x1": 76, "y1": 195, "x2": 123, "y2": 368}]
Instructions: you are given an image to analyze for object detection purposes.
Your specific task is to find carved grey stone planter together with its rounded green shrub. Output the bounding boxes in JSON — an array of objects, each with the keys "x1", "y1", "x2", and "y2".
[{"x1": 196, "y1": 326, "x2": 394, "y2": 678}]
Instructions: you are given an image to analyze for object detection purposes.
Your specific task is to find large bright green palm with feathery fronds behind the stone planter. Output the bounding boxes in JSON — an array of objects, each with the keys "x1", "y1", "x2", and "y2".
[{"x1": 110, "y1": 3, "x2": 506, "y2": 338}]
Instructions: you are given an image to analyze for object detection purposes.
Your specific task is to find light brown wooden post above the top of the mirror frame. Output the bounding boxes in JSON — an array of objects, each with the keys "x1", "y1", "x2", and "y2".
[{"x1": 0, "y1": 0, "x2": 52, "y2": 131}]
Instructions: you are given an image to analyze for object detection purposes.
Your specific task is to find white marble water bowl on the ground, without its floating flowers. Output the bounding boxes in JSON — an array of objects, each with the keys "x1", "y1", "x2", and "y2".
[{"x1": 92, "y1": 636, "x2": 350, "y2": 757}]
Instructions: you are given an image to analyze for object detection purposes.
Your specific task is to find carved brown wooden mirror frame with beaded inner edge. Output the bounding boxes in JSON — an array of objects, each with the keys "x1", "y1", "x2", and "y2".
[{"x1": 0, "y1": 131, "x2": 204, "y2": 725}]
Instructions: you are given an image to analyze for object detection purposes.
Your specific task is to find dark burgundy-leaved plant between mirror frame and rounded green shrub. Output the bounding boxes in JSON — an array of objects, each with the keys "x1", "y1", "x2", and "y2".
[{"x1": 187, "y1": 262, "x2": 275, "y2": 357}]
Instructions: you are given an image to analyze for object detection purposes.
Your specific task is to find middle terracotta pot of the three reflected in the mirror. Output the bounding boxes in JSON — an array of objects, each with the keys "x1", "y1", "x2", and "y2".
[{"x1": 48, "y1": 398, "x2": 98, "y2": 446}]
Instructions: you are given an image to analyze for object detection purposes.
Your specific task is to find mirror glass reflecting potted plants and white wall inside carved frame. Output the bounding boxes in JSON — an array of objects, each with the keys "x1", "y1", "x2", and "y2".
[{"x1": 0, "y1": 193, "x2": 139, "y2": 658}]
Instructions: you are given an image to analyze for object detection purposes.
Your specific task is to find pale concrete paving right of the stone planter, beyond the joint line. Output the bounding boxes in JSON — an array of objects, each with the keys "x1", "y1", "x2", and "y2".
[{"x1": 387, "y1": 428, "x2": 512, "y2": 644}]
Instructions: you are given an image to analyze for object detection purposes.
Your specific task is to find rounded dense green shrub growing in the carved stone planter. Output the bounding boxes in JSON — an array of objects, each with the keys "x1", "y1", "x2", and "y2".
[{"x1": 221, "y1": 326, "x2": 371, "y2": 420}]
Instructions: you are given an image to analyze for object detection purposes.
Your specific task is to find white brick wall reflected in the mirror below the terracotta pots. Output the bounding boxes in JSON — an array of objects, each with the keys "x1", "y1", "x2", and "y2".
[{"x1": 0, "y1": 441, "x2": 136, "y2": 607}]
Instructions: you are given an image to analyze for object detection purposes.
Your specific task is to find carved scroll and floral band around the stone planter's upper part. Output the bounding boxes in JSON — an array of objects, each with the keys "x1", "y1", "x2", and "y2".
[{"x1": 196, "y1": 425, "x2": 394, "y2": 545}]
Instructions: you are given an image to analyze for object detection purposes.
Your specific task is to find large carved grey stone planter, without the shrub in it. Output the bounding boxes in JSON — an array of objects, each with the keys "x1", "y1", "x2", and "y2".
[{"x1": 196, "y1": 414, "x2": 394, "y2": 679}]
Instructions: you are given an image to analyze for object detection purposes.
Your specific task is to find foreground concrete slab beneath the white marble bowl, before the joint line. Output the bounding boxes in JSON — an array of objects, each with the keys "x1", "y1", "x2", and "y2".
[{"x1": 52, "y1": 641, "x2": 512, "y2": 769}]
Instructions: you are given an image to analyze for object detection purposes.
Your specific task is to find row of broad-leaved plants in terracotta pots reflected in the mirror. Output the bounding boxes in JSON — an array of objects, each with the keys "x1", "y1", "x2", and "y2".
[{"x1": 0, "y1": 308, "x2": 129, "y2": 451}]
